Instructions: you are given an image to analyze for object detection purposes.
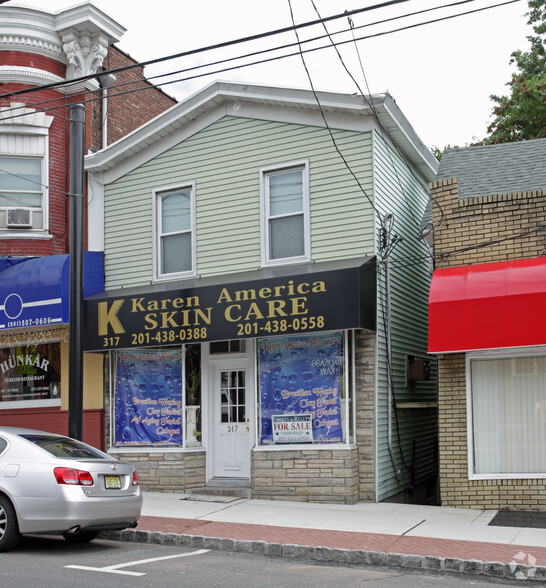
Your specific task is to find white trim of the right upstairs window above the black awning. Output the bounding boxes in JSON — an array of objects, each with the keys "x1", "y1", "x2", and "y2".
[{"x1": 260, "y1": 159, "x2": 311, "y2": 267}]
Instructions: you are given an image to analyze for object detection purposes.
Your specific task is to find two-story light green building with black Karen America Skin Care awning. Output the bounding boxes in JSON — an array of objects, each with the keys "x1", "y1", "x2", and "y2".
[{"x1": 85, "y1": 82, "x2": 437, "y2": 503}]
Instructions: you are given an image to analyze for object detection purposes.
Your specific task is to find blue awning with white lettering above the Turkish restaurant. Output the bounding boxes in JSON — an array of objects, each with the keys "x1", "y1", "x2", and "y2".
[{"x1": 0, "y1": 251, "x2": 104, "y2": 330}]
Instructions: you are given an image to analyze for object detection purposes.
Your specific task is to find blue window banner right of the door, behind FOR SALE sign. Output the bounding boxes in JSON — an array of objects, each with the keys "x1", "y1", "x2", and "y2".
[{"x1": 258, "y1": 332, "x2": 344, "y2": 445}]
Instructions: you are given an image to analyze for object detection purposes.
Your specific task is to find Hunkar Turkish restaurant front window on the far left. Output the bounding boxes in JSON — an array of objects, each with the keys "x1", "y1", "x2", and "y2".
[{"x1": 0, "y1": 343, "x2": 61, "y2": 409}]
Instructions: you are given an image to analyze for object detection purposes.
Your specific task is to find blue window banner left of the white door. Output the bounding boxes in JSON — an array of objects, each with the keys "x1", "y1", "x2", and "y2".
[{"x1": 112, "y1": 349, "x2": 183, "y2": 447}]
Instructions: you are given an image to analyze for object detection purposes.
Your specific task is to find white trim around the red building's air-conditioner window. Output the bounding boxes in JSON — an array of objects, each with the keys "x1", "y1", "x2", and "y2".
[{"x1": 0, "y1": 124, "x2": 53, "y2": 239}]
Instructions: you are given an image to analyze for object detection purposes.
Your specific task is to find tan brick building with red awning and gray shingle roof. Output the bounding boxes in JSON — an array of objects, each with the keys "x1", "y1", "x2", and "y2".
[{"x1": 429, "y1": 139, "x2": 546, "y2": 511}]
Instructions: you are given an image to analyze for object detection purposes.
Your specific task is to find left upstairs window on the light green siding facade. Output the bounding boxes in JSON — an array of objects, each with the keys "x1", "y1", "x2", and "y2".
[{"x1": 154, "y1": 184, "x2": 195, "y2": 279}]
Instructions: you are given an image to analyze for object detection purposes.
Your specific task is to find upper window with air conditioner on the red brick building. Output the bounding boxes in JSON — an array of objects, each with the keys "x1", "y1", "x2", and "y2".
[{"x1": 0, "y1": 103, "x2": 53, "y2": 238}]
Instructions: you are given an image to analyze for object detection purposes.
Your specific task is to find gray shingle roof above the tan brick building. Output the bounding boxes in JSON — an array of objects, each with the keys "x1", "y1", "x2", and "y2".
[{"x1": 436, "y1": 139, "x2": 546, "y2": 199}]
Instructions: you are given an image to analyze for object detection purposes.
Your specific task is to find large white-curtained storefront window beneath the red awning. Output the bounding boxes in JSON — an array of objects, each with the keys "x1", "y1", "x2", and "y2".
[{"x1": 469, "y1": 356, "x2": 546, "y2": 478}]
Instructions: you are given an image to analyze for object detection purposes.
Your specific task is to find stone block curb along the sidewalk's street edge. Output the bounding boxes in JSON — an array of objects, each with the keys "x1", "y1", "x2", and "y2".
[{"x1": 100, "y1": 529, "x2": 546, "y2": 582}]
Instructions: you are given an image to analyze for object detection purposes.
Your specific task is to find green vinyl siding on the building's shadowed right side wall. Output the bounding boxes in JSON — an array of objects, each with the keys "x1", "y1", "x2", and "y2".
[{"x1": 374, "y1": 134, "x2": 437, "y2": 500}]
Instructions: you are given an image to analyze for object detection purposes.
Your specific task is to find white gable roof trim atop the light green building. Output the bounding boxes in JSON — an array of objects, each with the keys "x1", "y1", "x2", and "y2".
[{"x1": 85, "y1": 82, "x2": 437, "y2": 183}]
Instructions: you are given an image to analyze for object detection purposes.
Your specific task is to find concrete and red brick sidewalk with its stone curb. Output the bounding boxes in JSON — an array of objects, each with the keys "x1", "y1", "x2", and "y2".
[{"x1": 103, "y1": 492, "x2": 546, "y2": 581}]
